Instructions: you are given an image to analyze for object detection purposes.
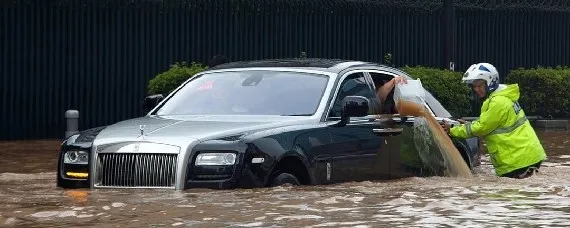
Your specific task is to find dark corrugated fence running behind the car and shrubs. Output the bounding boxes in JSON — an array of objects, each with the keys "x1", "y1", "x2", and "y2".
[{"x1": 0, "y1": 0, "x2": 570, "y2": 140}]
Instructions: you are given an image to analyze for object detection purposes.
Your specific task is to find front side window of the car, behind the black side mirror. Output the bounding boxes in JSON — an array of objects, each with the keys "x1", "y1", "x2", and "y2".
[{"x1": 329, "y1": 72, "x2": 376, "y2": 117}]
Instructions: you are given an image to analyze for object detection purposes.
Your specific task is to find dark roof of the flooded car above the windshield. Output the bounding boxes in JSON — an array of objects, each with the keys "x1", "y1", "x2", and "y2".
[{"x1": 202, "y1": 58, "x2": 386, "y2": 73}]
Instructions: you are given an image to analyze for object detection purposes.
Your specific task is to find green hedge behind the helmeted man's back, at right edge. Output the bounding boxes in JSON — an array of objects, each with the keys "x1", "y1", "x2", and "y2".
[{"x1": 505, "y1": 67, "x2": 570, "y2": 117}]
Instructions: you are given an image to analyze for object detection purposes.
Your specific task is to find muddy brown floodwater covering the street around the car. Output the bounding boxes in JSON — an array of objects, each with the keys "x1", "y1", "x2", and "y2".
[{"x1": 0, "y1": 131, "x2": 570, "y2": 227}]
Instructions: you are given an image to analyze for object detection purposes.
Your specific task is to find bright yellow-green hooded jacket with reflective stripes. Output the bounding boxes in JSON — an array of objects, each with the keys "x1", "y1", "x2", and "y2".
[{"x1": 450, "y1": 84, "x2": 546, "y2": 176}]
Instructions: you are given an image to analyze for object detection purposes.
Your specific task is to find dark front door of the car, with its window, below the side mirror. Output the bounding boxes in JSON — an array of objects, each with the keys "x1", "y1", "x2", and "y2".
[{"x1": 327, "y1": 71, "x2": 390, "y2": 183}]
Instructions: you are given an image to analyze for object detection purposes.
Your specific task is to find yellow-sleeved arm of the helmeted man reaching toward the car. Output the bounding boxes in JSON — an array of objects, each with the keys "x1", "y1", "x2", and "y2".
[{"x1": 449, "y1": 97, "x2": 510, "y2": 139}]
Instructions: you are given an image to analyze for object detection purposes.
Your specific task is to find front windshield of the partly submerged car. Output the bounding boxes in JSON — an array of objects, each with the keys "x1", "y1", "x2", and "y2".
[{"x1": 156, "y1": 70, "x2": 328, "y2": 116}]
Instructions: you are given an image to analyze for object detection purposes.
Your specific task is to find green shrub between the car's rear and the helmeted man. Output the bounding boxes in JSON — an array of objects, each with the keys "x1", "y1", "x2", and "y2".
[{"x1": 394, "y1": 66, "x2": 473, "y2": 117}]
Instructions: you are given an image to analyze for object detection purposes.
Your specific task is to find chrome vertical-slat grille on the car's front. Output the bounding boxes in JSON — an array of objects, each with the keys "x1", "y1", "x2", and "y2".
[{"x1": 95, "y1": 153, "x2": 178, "y2": 187}]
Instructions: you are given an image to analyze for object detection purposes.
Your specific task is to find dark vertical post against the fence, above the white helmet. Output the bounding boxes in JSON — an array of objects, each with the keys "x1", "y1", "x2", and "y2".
[{"x1": 443, "y1": 0, "x2": 457, "y2": 71}]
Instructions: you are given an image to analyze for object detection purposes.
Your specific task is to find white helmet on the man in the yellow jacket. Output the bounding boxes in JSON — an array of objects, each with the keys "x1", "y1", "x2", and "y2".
[{"x1": 461, "y1": 63, "x2": 499, "y2": 92}]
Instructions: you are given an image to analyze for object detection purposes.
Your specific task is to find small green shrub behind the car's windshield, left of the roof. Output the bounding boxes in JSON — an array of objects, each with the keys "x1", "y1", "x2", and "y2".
[{"x1": 147, "y1": 62, "x2": 207, "y2": 96}]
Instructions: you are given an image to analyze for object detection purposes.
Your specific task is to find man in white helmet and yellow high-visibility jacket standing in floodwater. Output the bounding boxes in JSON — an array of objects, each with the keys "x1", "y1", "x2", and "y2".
[{"x1": 442, "y1": 63, "x2": 546, "y2": 178}]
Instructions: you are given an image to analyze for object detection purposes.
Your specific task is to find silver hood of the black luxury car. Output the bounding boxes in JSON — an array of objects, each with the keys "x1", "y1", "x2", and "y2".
[{"x1": 94, "y1": 116, "x2": 317, "y2": 147}]
